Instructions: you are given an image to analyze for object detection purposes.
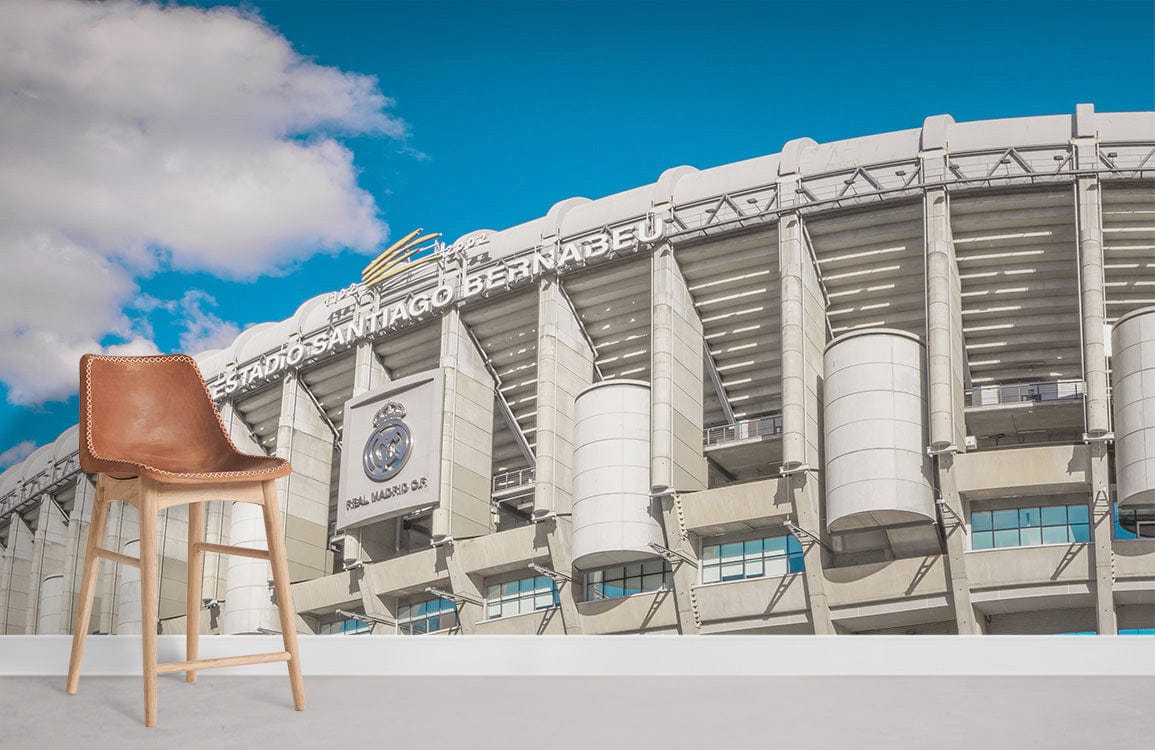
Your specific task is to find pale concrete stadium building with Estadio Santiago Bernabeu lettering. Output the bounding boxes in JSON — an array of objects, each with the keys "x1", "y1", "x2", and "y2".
[{"x1": 0, "y1": 104, "x2": 1155, "y2": 634}]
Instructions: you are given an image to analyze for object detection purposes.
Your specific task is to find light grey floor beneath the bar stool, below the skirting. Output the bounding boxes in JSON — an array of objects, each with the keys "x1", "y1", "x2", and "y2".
[{"x1": 0, "y1": 673, "x2": 1155, "y2": 750}]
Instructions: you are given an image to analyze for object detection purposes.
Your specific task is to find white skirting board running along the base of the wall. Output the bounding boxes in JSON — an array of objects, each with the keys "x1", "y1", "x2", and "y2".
[{"x1": 0, "y1": 636, "x2": 1155, "y2": 677}]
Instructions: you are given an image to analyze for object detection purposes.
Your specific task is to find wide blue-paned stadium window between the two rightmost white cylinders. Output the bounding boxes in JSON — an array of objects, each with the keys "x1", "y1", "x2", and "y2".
[{"x1": 970, "y1": 504, "x2": 1090, "y2": 550}]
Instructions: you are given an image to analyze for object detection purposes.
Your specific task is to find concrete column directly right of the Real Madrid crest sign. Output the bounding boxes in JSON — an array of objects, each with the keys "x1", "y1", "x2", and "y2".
[{"x1": 432, "y1": 307, "x2": 494, "y2": 540}]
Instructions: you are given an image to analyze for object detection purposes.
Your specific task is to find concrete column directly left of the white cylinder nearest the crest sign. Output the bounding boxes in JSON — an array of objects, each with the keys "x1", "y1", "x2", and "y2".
[{"x1": 534, "y1": 277, "x2": 594, "y2": 518}]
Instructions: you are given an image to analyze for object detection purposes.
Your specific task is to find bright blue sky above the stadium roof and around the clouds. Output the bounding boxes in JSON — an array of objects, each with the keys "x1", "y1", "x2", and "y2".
[{"x1": 0, "y1": 0, "x2": 1155, "y2": 462}]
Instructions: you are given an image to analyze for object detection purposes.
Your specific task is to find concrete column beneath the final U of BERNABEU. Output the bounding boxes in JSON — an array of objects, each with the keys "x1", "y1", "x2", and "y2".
[{"x1": 650, "y1": 245, "x2": 708, "y2": 492}]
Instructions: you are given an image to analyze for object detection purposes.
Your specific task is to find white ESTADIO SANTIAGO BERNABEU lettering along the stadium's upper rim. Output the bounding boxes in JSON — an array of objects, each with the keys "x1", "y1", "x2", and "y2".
[{"x1": 209, "y1": 214, "x2": 665, "y2": 400}]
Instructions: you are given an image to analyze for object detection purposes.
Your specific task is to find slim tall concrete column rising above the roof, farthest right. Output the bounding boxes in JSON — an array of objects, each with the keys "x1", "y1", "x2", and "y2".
[{"x1": 1073, "y1": 104, "x2": 1111, "y2": 438}]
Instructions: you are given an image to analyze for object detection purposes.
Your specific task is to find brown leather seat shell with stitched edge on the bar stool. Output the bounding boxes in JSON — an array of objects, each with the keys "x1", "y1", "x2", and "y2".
[{"x1": 80, "y1": 355, "x2": 292, "y2": 484}]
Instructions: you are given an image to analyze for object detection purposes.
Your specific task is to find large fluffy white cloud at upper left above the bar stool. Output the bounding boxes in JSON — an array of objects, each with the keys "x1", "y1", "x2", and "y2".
[{"x1": 0, "y1": 0, "x2": 404, "y2": 404}]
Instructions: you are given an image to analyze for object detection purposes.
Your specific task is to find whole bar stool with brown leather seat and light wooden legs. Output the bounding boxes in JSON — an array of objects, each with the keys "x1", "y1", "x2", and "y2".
[{"x1": 68, "y1": 355, "x2": 305, "y2": 727}]
